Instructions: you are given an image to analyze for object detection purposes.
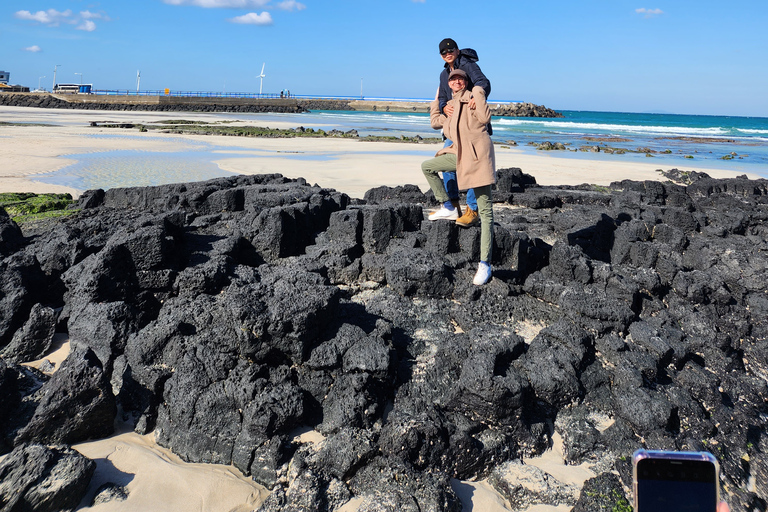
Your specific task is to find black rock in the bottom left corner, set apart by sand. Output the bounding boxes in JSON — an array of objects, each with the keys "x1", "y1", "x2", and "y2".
[{"x1": 0, "y1": 444, "x2": 96, "y2": 512}]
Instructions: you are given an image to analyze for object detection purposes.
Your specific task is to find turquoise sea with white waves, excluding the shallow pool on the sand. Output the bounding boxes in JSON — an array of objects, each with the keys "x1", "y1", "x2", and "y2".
[{"x1": 262, "y1": 111, "x2": 768, "y2": 178}]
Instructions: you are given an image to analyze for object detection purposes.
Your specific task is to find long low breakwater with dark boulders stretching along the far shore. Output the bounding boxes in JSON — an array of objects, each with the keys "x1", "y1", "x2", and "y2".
[{"x1": 0, "y1": 93, "x2": 563, "y2": 117}]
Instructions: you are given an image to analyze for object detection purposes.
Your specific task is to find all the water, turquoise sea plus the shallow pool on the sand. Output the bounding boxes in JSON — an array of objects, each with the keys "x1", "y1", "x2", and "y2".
[{"x1": 37, "y1": 111, "x2": 768, "y2": 190}]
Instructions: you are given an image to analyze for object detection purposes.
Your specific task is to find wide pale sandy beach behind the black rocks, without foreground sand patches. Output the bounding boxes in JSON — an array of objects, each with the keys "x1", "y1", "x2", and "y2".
[{"x1": 0, "y1": 107, "x2": 759, "y2": 197}]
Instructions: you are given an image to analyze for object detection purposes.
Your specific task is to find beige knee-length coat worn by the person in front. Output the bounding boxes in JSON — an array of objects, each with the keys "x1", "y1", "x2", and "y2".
[{"x1": 430, "y1": 87, "x2": 496, "y2": 190}]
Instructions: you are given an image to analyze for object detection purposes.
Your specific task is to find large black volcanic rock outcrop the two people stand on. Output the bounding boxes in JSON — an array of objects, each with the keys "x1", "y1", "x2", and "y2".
[{"x1": 0, "y1": 169, "x2": 768, "y2": 511}]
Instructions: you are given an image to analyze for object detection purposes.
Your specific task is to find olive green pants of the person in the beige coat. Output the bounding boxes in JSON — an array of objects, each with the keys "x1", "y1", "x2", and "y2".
[{"x1": 421, "y1": 153, "x2": 493, "y2": 263}]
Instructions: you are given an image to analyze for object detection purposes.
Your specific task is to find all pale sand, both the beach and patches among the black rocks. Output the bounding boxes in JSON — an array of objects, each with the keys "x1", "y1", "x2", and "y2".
[{"x1": 0, "y1": 107, "x2": 758, "y2": 512}]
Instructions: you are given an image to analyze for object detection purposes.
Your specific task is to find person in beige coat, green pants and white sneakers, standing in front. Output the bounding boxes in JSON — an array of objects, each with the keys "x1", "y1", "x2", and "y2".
[{"x1": 421, "y1": 69, "x2": 496, "y2": 286}]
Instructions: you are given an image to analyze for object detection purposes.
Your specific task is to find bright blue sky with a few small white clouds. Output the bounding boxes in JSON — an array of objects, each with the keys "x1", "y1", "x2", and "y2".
[{"x1": 0, "y1": 0, "x2": 768, "y2": 117}]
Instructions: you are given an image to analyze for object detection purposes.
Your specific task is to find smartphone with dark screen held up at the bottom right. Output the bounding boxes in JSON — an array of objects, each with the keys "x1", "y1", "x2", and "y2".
[{"x1": 632, "y1": 450, "x2": 720, "y2": 512}]
